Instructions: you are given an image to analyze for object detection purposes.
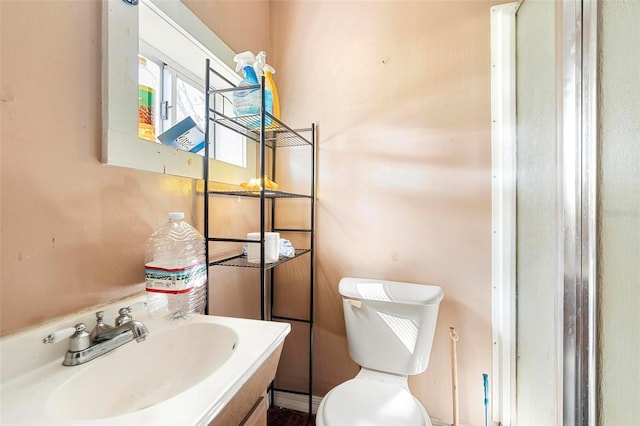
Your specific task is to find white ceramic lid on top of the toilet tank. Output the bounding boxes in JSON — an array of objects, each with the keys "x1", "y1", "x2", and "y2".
[{"x1": 338, "y1": 277, "x2": 444, "y2": 305}]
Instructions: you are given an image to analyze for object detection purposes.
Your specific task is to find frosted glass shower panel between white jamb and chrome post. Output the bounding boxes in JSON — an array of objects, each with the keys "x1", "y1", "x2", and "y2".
[{"x1": 516, "y1": 0, "x2": 561, "y2": 425}]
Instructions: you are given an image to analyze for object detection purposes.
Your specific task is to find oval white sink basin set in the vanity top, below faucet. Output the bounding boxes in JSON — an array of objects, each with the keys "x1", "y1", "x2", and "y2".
[{"x1": 47, "y1": 323, "x2": 238, "y2": 420}]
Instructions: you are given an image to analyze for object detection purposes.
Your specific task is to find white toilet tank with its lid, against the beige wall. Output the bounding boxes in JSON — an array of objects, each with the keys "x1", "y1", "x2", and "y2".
[{"x1": 339, "y1": 278, "x2": 444, "y2": 375}]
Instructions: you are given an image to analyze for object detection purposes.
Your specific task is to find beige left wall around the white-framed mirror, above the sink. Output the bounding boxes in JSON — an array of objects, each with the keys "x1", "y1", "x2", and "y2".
[{"x1": 0, "y1": 0, "x2": 268, "y2": 334}]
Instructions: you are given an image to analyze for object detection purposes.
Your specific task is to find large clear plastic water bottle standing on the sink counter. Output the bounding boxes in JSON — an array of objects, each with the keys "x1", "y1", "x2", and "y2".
[{"x1": 144, "y1": 212, "x2": 207, "y2": 320}]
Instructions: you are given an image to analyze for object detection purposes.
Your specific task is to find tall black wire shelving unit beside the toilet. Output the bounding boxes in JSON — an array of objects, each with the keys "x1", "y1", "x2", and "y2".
[{"x1": 204, "y1": 59, "x2": 316, "y2": 414}]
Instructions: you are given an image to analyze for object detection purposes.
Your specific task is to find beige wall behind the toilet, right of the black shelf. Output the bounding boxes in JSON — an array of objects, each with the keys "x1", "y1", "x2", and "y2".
[{"x1": 270, "y1": 1, "x2": 491, "y2": 425}]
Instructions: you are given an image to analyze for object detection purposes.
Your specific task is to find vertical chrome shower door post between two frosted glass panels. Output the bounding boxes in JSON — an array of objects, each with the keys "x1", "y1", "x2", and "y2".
[{"x1": 557, "y1": 0, "x2": 598, "y2": 425}]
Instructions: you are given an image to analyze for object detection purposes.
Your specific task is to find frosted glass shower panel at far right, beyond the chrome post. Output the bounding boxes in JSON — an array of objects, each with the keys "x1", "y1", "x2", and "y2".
[{"x1": 598, "y1": 0, "x2": 640, "y2": 426}]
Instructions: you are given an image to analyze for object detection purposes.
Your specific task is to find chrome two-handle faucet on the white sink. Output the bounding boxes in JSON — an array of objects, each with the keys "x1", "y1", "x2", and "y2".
[{"x1": 42, "y1": 307, "x2": 149, "y2": 366}]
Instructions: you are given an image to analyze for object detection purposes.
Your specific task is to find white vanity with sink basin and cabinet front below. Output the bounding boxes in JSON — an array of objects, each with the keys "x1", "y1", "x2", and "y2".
[{"x1": 0, "y1": 295, "x2": 290, "y2": 426}]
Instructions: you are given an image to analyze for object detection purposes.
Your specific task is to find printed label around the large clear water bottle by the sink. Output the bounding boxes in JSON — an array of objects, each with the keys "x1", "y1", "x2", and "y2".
[{"x1": 144, "y1": 262, "x2": 207, "y2": 294}]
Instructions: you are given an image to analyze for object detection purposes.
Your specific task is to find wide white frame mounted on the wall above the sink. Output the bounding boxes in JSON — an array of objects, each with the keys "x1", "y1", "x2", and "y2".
[{"x1": 102, "y1": 0, "x2": 256, "y2": 181}]
